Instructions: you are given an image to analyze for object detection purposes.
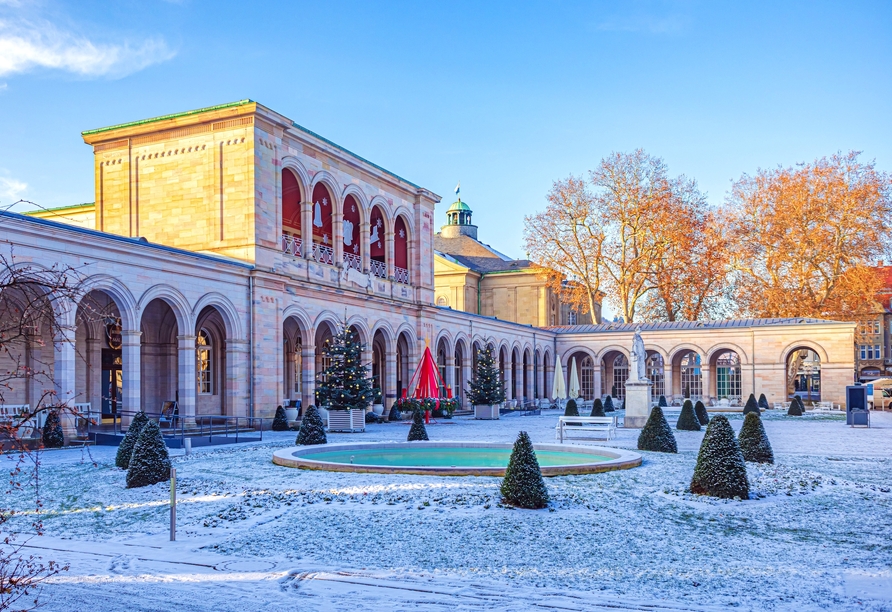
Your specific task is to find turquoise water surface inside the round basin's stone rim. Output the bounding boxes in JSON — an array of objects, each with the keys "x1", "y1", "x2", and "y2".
[{"x1": 305, "y1": 447, "x2": 611, "y2": 468}]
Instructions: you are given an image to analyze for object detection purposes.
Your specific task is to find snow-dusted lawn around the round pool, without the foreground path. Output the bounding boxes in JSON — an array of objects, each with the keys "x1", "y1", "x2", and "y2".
[{"x1": 5, "y1": 412, "x2": 892, "y2": 610}]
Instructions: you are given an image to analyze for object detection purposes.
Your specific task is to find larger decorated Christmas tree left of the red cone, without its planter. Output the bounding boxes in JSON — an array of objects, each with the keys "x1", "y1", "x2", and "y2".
[{"x1": 316, "y1": 321, "x2": 375, "y2": 410}]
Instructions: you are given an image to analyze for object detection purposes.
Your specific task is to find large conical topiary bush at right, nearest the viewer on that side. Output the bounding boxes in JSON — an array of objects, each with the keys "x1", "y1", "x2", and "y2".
[{"x1": 691, "y1": 414, "x2": 749, "y2": 499}]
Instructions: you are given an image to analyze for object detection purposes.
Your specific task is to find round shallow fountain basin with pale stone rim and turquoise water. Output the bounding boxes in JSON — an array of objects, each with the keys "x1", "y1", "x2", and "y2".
[{"x1": 273, "y1": 442, "x2": 641, "y2": 476}]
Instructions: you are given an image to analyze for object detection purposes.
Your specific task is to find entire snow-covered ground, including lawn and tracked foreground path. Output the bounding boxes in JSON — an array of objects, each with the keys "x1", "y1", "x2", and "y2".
[{"x1": 6, "y1": 413, "x2": 892, "y2": 612}]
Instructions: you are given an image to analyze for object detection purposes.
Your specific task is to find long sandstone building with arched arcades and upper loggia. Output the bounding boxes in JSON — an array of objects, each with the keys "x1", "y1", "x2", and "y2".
[{"x1": 0, "y1": 100, "x2": 854, "y2": 436}]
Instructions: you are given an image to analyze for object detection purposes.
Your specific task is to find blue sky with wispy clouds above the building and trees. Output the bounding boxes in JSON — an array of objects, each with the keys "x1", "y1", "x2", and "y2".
[{"x1": 0, "y1": 0, "x2": 892, "y2": 256}]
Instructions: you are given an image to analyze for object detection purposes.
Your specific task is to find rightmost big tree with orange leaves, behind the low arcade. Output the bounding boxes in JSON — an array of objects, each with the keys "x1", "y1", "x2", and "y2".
[{"x1": 725, "y1": 151, "x2": 892, "y2": 319}]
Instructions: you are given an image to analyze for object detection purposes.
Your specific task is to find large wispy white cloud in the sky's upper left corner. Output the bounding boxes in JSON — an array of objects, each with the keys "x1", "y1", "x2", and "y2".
[{"x1": 0, "y1": 18, "x2": 176, "y2": 77}]
